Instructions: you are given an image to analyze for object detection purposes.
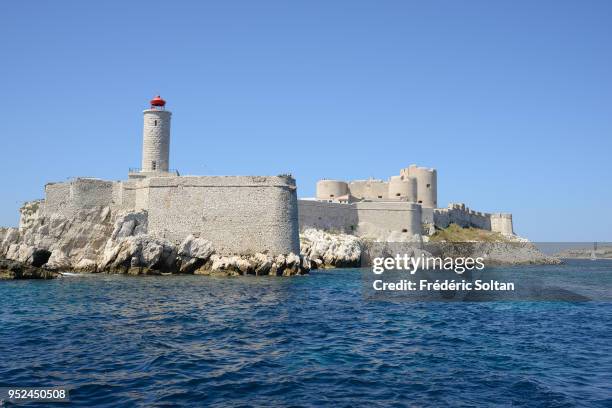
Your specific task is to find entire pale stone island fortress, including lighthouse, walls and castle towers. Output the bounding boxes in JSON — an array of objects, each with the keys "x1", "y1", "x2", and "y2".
[{"x1": 20, "y1": 96, "x2": 513, "y2": 256}]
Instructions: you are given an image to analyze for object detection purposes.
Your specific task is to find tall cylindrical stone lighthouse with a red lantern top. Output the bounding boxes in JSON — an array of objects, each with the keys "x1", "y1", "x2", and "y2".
[{"x1": 141, "y1": 95, "x2": 172, "y2": 172}]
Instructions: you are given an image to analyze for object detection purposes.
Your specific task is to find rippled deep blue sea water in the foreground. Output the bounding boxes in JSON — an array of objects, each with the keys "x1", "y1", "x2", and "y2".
[{"x1": 0, "y1": 261, "x2": 612, "y2": 407}]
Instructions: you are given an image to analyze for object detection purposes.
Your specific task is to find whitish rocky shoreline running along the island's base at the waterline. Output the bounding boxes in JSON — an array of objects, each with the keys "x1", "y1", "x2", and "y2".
[{"x1": 0, "y1": 202, "x2": 560, "y2": 279}]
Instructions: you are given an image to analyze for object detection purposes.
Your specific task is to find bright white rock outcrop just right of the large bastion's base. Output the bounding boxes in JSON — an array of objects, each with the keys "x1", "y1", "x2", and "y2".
[{"x1": 300, "y1": 228, "x2": 361, "y2": 268}]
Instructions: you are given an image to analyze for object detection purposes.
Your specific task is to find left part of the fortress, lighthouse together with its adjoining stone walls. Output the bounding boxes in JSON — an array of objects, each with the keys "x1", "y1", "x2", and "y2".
[{"x1": 37, "y1": 96, "x2": 300, "y2": 255}]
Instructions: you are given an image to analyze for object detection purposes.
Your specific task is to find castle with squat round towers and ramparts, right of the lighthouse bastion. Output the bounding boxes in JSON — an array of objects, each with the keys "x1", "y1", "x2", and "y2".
[{"x1": 298, "y1": 164, "x2": 514, "y2": 237}]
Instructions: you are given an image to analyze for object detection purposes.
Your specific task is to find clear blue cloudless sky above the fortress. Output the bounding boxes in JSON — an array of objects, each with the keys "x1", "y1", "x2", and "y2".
[{"x1": 0, "y1": 0, "x2": 612, "y2": 241}]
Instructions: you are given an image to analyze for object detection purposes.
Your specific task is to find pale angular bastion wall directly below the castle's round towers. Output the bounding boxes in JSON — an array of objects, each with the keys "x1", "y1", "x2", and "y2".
[{"x1": 354, "y1": 202, "x2": 422, "y2": 234}]
